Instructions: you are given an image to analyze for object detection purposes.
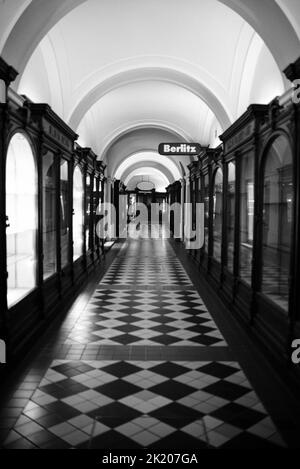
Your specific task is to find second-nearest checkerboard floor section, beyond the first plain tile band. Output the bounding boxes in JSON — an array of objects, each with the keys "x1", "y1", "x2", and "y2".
[{"x1": 66, "y1": 285, "x2": 226, "y2": 346}]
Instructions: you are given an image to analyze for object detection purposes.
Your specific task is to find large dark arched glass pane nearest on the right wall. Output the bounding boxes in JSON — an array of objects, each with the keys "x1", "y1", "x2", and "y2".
[{"x1": 262, "y1": 137, "x2": 293, "y2": 311}]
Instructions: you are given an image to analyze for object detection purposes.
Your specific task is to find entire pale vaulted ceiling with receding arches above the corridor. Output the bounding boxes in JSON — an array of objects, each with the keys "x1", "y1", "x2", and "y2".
[{"x1": 0, "y1": 0, "x2": 300, "y2": 190}]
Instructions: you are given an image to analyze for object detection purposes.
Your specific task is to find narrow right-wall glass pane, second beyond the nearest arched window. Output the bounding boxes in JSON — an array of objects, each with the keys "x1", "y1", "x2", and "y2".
[{"x1": 226, "y1": 163, "x2": 235, "y2": 272}]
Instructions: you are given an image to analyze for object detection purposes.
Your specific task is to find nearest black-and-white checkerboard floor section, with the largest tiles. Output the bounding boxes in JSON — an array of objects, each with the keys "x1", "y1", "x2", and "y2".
[{"x1": 4, "y1": 360, "x2": 284, "y2": 449}]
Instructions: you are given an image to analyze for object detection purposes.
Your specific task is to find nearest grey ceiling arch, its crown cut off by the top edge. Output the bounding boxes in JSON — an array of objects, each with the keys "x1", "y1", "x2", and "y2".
[{"x1": 2, "y1": 0, "x2": 299, "y2": 81}]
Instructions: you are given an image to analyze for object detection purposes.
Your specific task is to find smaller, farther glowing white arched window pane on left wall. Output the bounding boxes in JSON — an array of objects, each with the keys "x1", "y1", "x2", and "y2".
[{"x1": 73, "y1": 166, "x2": 84, "y2": 260}]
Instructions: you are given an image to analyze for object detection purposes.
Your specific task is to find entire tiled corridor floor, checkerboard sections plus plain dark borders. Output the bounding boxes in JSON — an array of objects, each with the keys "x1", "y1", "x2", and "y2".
[{"x1": 1, "y1": 239, "x2": 286, "y2": 449}]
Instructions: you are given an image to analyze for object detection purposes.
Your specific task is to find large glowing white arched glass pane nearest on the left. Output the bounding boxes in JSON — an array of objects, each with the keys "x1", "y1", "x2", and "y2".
[{"x1": 6, "y1": 133, "x2": 38, "y2": 307}]
